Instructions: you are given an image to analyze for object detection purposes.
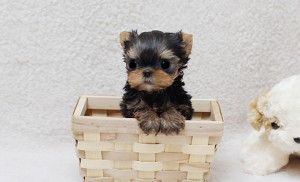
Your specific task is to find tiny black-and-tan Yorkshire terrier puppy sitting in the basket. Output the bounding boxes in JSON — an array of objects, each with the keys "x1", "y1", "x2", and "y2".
[{"x1": 120, "y1": 31, "x2": 193, "y2": 135}]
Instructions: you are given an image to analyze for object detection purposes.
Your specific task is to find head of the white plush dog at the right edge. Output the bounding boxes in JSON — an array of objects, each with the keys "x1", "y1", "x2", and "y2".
[{"x1": 248, "y1": 76, "x2": 300, "y2": 153}]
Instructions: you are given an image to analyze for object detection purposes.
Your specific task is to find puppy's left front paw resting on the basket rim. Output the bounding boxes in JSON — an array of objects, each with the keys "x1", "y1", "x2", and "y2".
[{"x1": 134, "y1": 112, "x2": 160, "y2": 135}]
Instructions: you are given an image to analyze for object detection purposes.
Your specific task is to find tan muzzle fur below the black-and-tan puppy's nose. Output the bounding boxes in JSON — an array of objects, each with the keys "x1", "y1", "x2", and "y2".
[{"x1": 128, "y1": 69, "x2": 174, "y2": 92}]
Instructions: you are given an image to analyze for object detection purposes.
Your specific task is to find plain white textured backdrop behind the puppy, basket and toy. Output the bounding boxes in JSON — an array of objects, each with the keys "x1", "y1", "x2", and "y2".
[{"x1": 0, "y1": 0, "x2": 300, "y2": 182}]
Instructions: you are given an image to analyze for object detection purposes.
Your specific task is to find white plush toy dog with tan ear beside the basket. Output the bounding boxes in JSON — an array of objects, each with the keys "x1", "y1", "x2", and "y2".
[{"x1": 242, "y1": 75, "x2": 300, "y2": 175}]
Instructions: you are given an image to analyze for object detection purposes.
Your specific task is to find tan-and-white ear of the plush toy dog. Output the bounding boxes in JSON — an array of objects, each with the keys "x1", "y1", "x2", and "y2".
[{"x1": 247, "y1": 90, "x2": 270, "y2": 131}]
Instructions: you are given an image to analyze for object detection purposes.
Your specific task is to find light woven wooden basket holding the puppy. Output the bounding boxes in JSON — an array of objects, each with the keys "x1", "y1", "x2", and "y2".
[{"x1": 72, "y1": 96, "x2": 223, "y2": 182}]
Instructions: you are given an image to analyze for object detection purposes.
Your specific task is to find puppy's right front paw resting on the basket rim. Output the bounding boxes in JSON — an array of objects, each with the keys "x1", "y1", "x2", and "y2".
[{"x1": 160, "y1": 109, "x2": 185, "y2": 135}]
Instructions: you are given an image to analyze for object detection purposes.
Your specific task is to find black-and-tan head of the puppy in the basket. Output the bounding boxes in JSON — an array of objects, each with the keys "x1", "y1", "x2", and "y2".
[{"x1": 120, "y1": 31, "x2": 192, "y2": 92}]
